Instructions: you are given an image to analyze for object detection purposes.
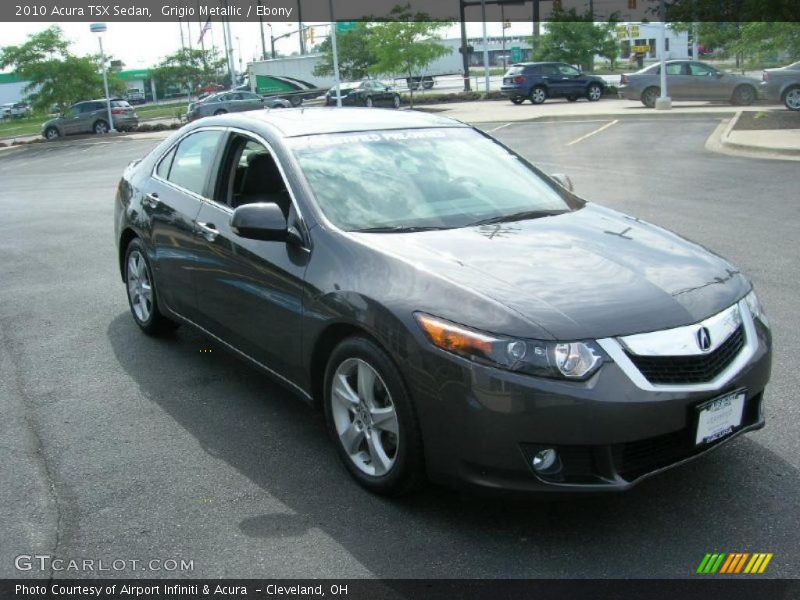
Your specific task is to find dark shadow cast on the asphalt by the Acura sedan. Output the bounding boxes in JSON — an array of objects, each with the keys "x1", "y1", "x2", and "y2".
[{"x1": 107, "y1": 313, "x2": 800, "y2": 578}]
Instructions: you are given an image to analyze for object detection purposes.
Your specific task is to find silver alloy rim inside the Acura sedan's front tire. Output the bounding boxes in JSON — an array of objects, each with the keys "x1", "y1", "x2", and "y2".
[{"x1": 330, "y1": 358, "x2": 400, "y2": 477}]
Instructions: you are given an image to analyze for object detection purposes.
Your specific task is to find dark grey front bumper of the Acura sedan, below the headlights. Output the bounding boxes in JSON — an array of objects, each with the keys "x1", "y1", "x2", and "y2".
[{"x1": 407, "y1": 304, "x2": 771, "y2": 492}]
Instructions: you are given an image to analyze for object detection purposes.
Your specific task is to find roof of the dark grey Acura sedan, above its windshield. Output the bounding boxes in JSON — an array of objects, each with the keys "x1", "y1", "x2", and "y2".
[{"x1": 209, "y1": 107, "x2": 467, "y2": 137}]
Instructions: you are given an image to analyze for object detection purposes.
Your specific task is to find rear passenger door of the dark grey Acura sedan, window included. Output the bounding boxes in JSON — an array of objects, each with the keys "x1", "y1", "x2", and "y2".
[{"x1": 147, "y1": 128, "x2": 225, "y2": 320}]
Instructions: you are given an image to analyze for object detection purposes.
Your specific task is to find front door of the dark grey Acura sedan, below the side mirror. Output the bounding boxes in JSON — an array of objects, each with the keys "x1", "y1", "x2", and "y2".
[{"x1": 194, "y1": 133, "x2": 308, "y2": 381}]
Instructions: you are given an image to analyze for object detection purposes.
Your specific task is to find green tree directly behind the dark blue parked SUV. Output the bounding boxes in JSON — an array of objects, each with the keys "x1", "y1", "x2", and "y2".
[{"x1": 531, "y1": 8, "x2": 619, "y2": 71}]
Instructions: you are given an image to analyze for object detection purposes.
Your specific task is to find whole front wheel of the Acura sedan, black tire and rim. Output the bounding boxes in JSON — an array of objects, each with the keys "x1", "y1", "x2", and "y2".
[{"x1": 324, "y1": 337, "x2": 425, "y2": 496}]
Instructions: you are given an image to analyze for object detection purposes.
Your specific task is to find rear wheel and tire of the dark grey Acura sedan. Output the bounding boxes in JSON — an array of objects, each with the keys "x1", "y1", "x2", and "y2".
[{"x1": 124, "y1": 238, "x2": 178, "y2": 335}]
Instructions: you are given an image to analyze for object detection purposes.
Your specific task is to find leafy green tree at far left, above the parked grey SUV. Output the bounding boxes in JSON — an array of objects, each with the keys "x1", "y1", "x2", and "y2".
[{"x1": 0, "y1": 25, "x2": 124, "y2": 112}]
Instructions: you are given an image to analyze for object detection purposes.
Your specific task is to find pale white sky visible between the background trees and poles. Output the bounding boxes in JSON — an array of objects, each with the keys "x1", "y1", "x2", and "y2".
[{"x1": 0, "y1": 20, "x2": 544, "y2": 69}]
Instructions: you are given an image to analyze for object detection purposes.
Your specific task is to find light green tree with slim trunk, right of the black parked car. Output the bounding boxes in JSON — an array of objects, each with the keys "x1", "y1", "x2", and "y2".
[{"x1": 369, "y1": 4, "x2": 450, "y2": 108}]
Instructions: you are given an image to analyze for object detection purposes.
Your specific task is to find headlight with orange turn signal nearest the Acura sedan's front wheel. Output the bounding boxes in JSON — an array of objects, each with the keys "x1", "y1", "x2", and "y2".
[{"x1": 414, "y1": 313, "x2": 606, "y2": 379}]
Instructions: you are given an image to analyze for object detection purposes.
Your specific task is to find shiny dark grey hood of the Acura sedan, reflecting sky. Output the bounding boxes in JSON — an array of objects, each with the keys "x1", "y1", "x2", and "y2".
[{"x1": 353, "y1": 204, "x2": 750, "y2": 340}]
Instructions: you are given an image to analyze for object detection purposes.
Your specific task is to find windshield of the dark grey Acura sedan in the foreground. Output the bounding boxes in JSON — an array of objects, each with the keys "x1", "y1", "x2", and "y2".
[{"x1": 289, "y1": 127, "x2": 571, "y2": 232}]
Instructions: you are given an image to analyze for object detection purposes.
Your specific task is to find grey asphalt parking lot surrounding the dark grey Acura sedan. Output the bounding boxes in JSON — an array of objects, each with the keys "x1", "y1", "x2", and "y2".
[{"x1": 0, "y1": 117, "x2": 800, "y2": 578}]
